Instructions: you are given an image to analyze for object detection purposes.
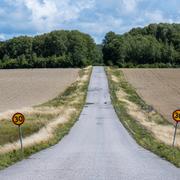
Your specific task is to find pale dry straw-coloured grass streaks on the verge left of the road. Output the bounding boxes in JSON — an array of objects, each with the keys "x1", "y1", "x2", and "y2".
[{"x1": 0, "y1": 67, "x2": 91, "y2": 154}]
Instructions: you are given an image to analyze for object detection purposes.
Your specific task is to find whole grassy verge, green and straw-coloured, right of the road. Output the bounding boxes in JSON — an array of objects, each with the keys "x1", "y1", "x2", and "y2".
[{"x1": 106, "y1": 68, "x2": 180, "y2": 167}]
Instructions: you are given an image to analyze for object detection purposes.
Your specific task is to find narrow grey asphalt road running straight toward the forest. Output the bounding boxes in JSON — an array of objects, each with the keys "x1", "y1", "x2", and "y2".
[{"x1": 0, "y1": 67, "x2": 180, "y2": 180}]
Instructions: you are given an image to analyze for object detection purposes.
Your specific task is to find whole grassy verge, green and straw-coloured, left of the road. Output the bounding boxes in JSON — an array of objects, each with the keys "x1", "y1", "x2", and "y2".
[{"x1": 0, "y1": 67, "x2": 92, "y2": 169}]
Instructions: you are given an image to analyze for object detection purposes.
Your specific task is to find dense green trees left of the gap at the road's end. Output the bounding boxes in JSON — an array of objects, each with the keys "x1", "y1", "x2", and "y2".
[{"x1": 0, "y1": 30, "x2": 102, "y2": 68}]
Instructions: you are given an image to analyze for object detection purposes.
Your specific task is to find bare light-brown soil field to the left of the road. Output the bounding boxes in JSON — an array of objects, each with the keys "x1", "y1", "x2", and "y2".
[{"x1": 0, "y1": 69, "x2": 79, "y2": 113}]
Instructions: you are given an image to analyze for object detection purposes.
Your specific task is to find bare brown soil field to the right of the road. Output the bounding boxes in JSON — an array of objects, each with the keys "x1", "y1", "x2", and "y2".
[{"x1": 122, "y1": 69, "x2": 180, "y2": 122}]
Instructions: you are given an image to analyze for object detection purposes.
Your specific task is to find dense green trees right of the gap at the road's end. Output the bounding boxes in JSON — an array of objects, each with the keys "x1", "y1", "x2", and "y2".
[{"x1": 102, "y1": 23, "x2": 180, "y2": 67}]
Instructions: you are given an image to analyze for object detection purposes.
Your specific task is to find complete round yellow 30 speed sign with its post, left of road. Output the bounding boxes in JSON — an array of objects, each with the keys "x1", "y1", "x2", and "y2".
[{"x1": 12, "y1": 113, "x2": 25, "y2": 157}]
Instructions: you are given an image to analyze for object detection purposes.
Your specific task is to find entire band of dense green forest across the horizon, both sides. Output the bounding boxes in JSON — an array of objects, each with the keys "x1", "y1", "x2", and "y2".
[{"x1": 0, "y1": 23, "x2": 180, "y2": 68}]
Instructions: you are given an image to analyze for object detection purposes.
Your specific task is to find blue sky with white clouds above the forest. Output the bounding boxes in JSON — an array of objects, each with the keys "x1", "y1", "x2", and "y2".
[{"x1": 0, "y1": 0, "x2": 180, "y2": 43}]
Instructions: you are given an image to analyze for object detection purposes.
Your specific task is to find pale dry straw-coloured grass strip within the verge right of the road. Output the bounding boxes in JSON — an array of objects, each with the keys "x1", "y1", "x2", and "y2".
[{"x1": 111, "y1": 70, "x2": 180, "y2": 147}]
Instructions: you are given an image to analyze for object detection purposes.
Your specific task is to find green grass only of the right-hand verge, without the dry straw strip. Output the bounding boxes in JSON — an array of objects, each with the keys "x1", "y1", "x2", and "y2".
[{"x1": 106, "y1": 68, "x2": 180, "y2": 167}]
